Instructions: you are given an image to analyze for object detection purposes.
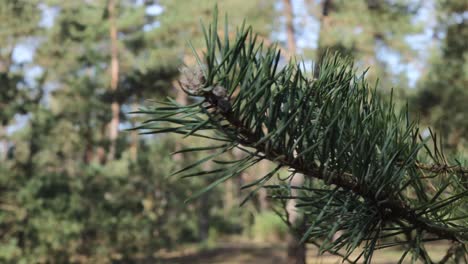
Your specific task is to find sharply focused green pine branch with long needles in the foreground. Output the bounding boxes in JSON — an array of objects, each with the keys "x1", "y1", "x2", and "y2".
[{"x1": 137, "y1": 9, "x2": 468, "y2": 263}]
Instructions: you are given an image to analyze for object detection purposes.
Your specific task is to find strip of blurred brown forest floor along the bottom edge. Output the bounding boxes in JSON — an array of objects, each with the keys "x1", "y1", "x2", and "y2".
[{"x1": 156, "y1": 242, "x2": 448, "y2": 264}]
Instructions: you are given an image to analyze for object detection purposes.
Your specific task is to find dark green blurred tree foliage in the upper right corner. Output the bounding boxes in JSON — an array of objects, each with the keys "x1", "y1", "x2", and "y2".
[{"x1": 414, "y1": 0, "x2": 468, "y2": 153}]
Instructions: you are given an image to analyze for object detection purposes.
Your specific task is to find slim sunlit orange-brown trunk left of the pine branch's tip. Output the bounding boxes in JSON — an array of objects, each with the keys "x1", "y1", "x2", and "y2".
[{"x1": 107, "y1": 0, "x2": 120, "y2": 160}]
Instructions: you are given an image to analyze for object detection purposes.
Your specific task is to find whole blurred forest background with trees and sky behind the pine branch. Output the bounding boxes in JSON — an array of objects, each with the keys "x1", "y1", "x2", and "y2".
[{"x1": 0, "y1": 0, "x2": 468, "y2": 263}]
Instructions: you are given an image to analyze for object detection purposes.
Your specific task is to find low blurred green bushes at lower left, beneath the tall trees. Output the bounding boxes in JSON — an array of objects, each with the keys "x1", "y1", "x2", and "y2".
[{"x1": 0, "y1": 136, "x2": 227, "y2": 263}]
